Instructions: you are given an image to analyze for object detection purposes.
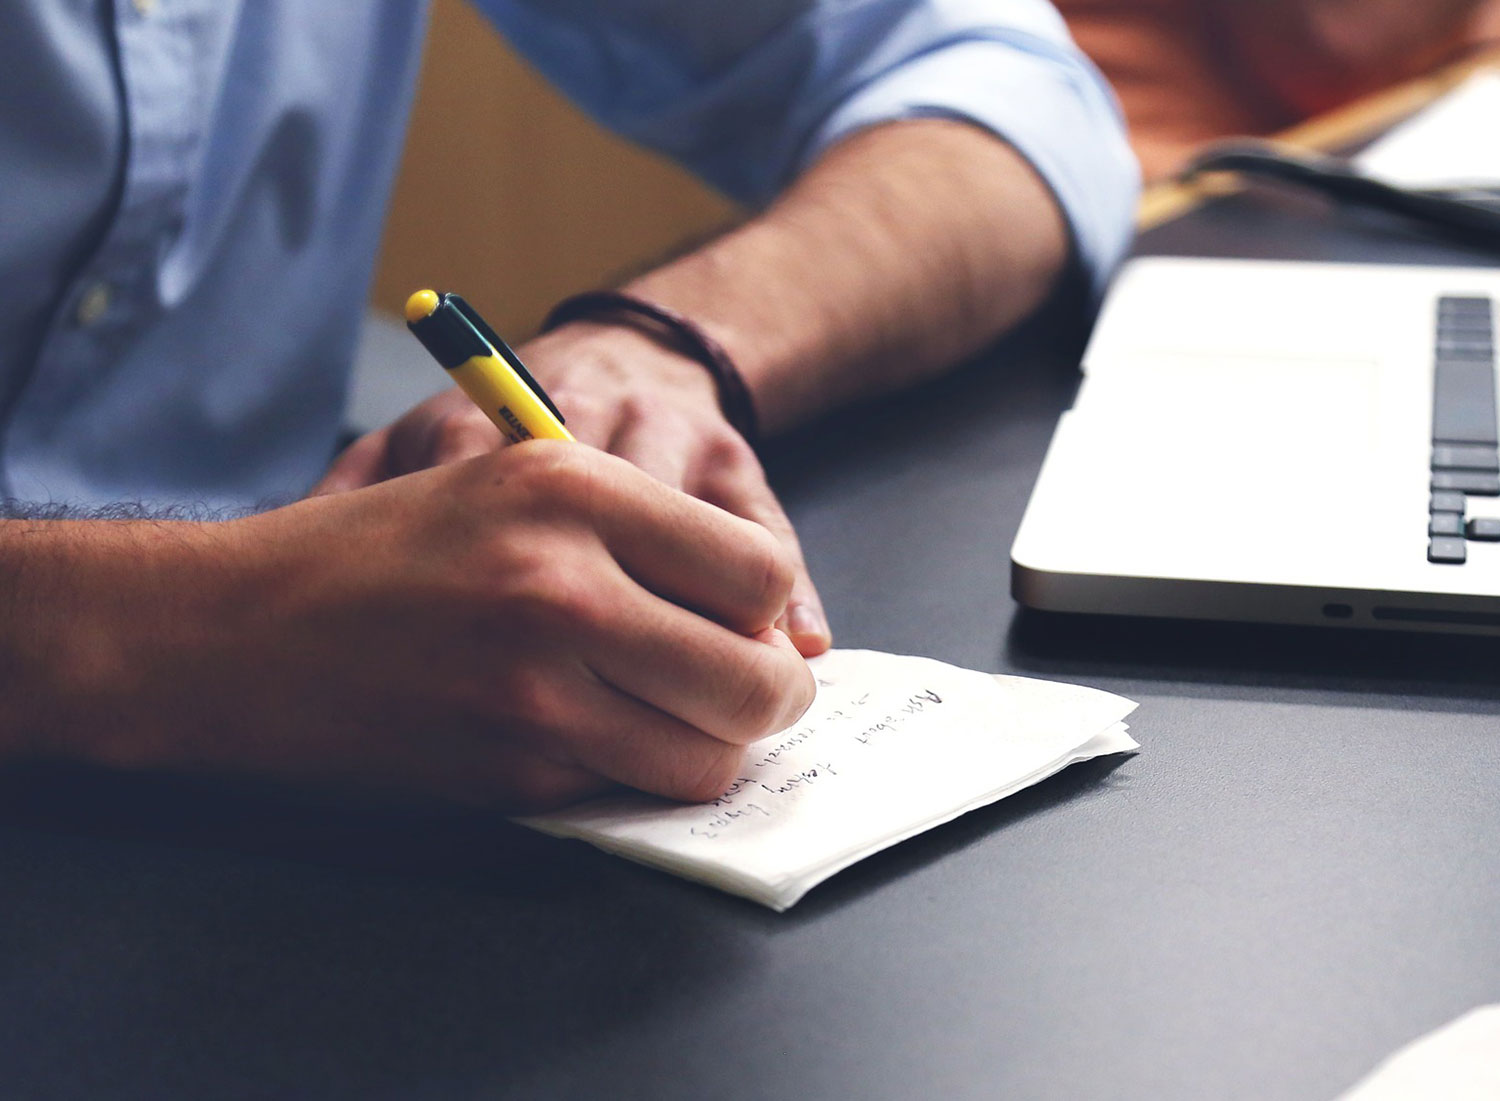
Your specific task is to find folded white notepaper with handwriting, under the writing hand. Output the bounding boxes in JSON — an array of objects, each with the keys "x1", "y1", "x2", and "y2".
[{"x1": 521, "y1": 650, "x2": 1139, "y2": 911}]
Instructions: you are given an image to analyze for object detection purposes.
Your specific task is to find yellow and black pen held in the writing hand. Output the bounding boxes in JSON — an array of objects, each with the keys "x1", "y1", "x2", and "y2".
[{"x1": 407, "y1": 291, "x2": 573, "y2": 444}]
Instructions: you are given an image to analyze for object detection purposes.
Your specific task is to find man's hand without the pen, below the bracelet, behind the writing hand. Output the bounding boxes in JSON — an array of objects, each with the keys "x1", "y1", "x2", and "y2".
[{"x1": 314, "y1": 324, "x2": 831, "y2": 657}]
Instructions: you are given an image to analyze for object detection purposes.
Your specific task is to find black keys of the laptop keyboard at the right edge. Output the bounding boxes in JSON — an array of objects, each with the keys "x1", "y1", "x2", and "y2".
[{"x1": 1427, "y1": 296, "x2": 1500, "y2": 566}]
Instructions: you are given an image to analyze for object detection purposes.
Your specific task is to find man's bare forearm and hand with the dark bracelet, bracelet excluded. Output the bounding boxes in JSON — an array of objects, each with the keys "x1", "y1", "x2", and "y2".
[{"x1": 315, "y1": 119, "x2": 1068, "y2": 669}]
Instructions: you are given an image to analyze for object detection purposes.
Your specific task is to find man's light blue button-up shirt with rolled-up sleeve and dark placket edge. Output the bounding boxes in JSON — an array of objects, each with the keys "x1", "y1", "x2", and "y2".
[{"x1": 0, "y1": 0, "x2": 1136, "y2": 509}]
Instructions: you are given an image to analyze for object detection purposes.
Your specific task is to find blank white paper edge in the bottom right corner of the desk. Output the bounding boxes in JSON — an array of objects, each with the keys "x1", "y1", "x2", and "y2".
[{"x1": 1340, "y1": 1005, "x2": 1500, "y2": 1101}]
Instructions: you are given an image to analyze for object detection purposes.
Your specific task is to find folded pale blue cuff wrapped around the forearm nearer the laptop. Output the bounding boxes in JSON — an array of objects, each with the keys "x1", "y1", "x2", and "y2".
[{"x1": 800, "y1": 38, "x2": 1140, "y2": 299}]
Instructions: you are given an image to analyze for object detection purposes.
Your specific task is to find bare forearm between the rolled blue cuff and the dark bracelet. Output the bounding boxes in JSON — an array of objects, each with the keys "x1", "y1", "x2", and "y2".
[{"x1": 629, "y1": 120, "x2": 1068, "y2": 431}]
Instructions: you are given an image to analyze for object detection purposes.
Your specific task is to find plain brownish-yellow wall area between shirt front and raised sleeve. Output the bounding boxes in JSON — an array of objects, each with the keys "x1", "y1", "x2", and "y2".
[{"x1": 374, "y1": 0, "x2": 735, "y2": 339}]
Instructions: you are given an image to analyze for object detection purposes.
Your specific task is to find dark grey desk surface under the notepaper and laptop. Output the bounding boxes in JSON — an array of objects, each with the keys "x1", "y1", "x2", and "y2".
[{"x1": 0, "y1": 192, "x2": 1500, "y2": 1100}]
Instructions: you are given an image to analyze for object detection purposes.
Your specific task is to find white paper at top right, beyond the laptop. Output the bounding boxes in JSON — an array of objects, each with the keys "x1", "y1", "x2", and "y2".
[{"x1": 1355, "y1": 71, "x2": 1500, "y2": 189}]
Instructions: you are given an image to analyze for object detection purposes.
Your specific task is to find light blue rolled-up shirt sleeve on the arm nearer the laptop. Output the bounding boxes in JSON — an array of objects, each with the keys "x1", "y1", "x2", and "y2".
[{"x1": 480, "y1": 0, "x2": 1139, "y2": 290}]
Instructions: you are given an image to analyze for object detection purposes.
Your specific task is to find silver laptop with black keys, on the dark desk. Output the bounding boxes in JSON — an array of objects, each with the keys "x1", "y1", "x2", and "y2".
[{"x1": 1011, "y1": 260, "x2": 1500, "y2": 635}]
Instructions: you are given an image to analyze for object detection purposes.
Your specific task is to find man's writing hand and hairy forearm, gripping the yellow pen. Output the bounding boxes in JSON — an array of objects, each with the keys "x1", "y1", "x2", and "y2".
[{"x1": 0, "y1": 441, "x2": 813, "y2": 812}]
